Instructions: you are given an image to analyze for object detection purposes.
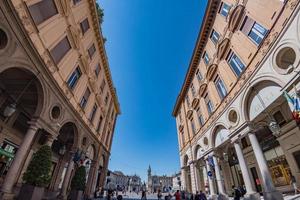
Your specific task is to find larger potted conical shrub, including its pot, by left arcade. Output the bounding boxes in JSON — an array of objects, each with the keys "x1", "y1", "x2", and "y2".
[{"x1": 17, "y1": 145, "x2": 52, "y2": 200}]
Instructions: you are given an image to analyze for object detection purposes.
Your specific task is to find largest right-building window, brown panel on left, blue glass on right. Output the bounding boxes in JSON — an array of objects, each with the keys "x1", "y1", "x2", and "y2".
[{"x1": 241, "y1": 17, "x2": 268, "y2": 45}]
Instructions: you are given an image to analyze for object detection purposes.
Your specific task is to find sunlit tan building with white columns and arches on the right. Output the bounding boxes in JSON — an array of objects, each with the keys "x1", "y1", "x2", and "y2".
[{"x1": 173, "y1": 0, "x2": 300, "y2": 200}]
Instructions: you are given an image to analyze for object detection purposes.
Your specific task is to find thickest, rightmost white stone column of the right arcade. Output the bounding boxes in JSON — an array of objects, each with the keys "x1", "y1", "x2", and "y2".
[{"x1": 248, "y1": 133, "x2": 283, "y2": 200}]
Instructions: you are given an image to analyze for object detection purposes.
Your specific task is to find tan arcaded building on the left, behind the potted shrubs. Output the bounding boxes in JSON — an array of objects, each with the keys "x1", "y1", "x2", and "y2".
[{"x1": 0, "y1": 0, "x2": 120, "y2": 199}]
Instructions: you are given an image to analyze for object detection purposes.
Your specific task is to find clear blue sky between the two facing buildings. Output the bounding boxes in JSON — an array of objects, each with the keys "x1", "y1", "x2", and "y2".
[{"x1": 99, "y1": 0, "x2": 206, "y2": 180}]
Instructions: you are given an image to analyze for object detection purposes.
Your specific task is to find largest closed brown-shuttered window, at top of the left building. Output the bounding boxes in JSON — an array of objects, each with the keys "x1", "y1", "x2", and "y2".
[{"x1": 28, "y1": 0, "x2": 58, "y2": 25}]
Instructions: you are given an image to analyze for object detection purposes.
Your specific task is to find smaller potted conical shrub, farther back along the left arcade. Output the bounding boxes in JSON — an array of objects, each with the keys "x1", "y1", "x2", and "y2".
[{"x1": 70, "y1": 165, "x2": 86, "y2": 200}]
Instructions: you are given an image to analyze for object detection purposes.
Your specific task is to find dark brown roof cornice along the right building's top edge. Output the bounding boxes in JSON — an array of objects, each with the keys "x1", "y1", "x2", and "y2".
[{"x1": 172, "y1": 0, "x2": 221, "y2": 117}]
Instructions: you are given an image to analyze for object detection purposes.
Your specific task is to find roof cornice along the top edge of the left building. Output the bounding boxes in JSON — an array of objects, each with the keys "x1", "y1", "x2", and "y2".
[{"x1": 88, "y1": 0, "x2": 121, "y2": 114}]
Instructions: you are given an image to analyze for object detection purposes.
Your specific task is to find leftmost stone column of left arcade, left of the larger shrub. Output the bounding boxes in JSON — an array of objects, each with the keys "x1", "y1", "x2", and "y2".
[{"x1": 0, "y1": 122, "x2": 38, "y2": 199}]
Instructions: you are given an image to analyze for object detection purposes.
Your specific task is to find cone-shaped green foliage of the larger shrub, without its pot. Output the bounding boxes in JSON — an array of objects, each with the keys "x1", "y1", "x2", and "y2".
[{"x1": 23, "y1": 145, "x2": 52, "y2": 187}]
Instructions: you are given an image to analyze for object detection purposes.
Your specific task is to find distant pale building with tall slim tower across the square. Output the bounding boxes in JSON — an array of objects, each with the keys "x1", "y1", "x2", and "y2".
[{"x1": 147, "y1": 166, "x2": 173, "y2": 192}]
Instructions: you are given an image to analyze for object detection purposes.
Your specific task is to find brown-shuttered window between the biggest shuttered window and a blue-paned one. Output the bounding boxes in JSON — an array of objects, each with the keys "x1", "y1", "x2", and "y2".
[{"x1": 50, "y1": 37, "x2": 71, "y2": 64}]
